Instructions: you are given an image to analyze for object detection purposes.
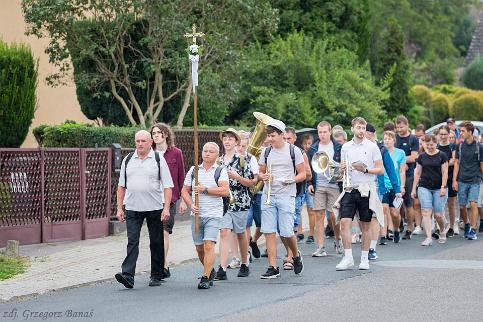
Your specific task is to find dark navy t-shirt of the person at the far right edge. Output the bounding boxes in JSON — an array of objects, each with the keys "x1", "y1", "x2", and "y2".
[{"x1": 456, "y1": 141, "x2": 483, "y2": 183}]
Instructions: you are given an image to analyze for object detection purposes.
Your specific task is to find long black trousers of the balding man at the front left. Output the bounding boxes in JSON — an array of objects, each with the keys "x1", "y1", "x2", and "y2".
[{"x1": 122, "y1": 210, "x2": 164, "y2": 279}]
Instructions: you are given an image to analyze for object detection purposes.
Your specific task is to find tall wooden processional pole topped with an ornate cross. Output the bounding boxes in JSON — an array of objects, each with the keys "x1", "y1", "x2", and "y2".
[{"x1": 184, "y1": 24, "x2": 205, "y2": 234}]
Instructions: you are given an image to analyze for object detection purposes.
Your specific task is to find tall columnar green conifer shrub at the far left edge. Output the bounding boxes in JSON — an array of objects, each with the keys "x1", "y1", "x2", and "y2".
[{"x1": 0, "y1": 41, "x2": 38, "y2": 148}]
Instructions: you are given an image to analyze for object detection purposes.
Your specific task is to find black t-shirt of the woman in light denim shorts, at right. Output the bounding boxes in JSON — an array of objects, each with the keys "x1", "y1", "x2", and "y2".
[{"x1": 416, "y1": 151, "x2": 448, "y2": 190}]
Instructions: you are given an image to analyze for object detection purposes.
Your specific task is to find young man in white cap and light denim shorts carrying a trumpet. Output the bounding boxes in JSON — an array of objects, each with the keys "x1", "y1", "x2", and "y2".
[{"x1": 258, "y1": 119, "x2": 306, "y2": 279}]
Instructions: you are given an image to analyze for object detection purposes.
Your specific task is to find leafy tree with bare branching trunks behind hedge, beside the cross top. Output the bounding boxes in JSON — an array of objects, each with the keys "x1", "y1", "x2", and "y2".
[{"x1": 22, "y1": 0, "x2": 277, "y2": 127}]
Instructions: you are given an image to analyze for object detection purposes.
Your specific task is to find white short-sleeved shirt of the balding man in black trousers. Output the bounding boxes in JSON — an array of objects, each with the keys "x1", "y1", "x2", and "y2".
[{"x1": 119, "y1": 149, "x2": 173, "y2": 211}]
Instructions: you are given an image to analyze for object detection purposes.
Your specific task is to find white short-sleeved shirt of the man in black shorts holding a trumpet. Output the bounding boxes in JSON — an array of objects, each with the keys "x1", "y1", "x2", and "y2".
[{"x1": 341, "y1": 138, "x2": 382, "y2": 185}]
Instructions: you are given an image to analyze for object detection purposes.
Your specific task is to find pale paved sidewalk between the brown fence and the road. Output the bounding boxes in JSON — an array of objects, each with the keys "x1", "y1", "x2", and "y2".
[{"x1": 0, "y1": 220, "x2": 197, "y2": 301}]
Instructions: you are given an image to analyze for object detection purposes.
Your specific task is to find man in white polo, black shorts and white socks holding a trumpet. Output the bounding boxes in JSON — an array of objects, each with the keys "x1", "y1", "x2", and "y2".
[{"x1": 333, "y1": 117, "x2": 384, "y2": 271}]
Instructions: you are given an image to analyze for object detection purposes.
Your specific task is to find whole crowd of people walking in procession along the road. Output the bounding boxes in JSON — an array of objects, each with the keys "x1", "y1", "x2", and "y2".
[{"x1": 110, "y1": 116, "x2": 483, "y2": 289}]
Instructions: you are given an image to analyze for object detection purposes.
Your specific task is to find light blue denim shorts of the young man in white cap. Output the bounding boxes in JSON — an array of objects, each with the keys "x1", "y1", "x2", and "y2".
[{"x1": 261, "y1": 194, "x2": 295, "y2": 237}]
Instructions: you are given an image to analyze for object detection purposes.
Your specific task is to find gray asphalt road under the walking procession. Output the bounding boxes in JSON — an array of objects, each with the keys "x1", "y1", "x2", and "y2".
[{"x1": 0, "y1": 236, "x2": 483, "y2": 322}]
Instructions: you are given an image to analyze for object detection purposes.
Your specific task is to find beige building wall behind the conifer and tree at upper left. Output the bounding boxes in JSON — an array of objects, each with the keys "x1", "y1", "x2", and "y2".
[{"x1": 0, "y1": 0, "x2": 89, "y2": 148}]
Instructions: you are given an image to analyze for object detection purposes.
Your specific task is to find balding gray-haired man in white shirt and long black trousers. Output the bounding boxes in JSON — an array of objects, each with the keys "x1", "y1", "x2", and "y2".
[{"x1": 115, "y1": 130, "x2": 173, "y2": 288}]
